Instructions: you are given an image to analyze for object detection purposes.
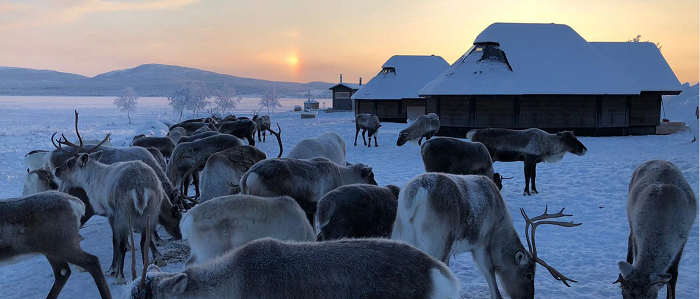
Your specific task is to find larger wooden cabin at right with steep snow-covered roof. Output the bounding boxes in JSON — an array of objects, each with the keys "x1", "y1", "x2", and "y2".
[{"x1": 418, "y1": 23, "x2": 681, "y2": 137}]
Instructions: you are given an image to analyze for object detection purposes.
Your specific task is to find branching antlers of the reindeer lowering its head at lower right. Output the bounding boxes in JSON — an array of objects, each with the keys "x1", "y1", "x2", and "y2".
[{"x1": 520, "y1": 205, "x2": 581, "y2": 287}]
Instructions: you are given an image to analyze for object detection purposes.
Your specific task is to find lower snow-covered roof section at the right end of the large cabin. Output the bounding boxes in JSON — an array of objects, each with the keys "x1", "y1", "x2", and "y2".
[{"x1": 590, "y1": 42, "x2": 682, "y2": 93}]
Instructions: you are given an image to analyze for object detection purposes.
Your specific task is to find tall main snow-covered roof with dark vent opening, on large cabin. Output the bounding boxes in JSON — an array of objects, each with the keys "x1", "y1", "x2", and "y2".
[{"x1": 418, "y1": 23, "x2": 668, "y2": 95}]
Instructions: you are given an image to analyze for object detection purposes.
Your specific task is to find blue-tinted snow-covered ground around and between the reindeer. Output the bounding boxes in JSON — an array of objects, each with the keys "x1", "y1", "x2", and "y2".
[{"x1": 0, "y1": 97, "x2": 699, "y2": 298}]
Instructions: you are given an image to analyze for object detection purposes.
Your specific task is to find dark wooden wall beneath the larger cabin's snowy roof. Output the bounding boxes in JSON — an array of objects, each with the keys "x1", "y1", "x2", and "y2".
[{"x1": 426, "y1": 94, "x2": 661, "y2": 138}]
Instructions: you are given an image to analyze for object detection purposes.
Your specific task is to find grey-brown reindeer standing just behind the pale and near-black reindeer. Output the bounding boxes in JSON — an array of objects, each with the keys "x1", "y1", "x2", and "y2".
[{"x1": 240, "y1": 158, "x2": 377, "y2": 225}]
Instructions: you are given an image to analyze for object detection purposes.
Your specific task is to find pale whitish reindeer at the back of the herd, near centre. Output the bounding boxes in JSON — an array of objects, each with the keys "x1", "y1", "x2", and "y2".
[{"x1": 287, "y1": 131, "x2": 347, "y2": 165}]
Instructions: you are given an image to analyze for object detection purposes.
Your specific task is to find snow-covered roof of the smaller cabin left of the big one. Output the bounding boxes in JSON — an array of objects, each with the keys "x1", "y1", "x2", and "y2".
[{"x1": 352, "y1": 55, "x2": 450, "y2": 100}]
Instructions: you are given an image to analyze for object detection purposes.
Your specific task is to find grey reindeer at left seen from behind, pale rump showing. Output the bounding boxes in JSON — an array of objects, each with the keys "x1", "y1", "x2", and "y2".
[{"x1": 54, "y1": 147, "x2": 167, "y2": 284}]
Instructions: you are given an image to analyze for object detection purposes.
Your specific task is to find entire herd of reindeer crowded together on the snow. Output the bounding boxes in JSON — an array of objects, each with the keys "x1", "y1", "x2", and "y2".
[{"x1": 0, "y1": 111, "x2": 697, "y2": 299}]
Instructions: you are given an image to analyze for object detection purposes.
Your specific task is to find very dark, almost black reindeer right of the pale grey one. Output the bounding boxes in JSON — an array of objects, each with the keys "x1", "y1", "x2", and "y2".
[{"x1": 316, "y1": 184, "x2": 401, "y2": 241}]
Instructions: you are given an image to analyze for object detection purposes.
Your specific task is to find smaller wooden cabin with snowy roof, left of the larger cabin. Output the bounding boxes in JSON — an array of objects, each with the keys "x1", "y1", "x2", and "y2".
[{"x1": 352, "y1": 55, "x2": 450, "y2": 123}]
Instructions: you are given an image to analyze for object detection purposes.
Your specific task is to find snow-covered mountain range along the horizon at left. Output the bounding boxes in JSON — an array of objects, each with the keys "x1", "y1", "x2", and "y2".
[{"x1": 0, "y1": 64, "x2": 332, "y2": 97}]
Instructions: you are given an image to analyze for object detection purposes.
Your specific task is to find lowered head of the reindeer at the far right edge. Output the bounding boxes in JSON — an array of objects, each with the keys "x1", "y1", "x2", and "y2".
[{"x1": 613, "y1": 262, "x2": 672, "y2": 299}]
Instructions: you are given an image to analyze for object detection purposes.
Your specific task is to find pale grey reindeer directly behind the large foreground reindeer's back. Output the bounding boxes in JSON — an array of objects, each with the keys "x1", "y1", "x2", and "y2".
[{"x1": 180, "y1": 195, "x2": 316, "y2": 264}]
